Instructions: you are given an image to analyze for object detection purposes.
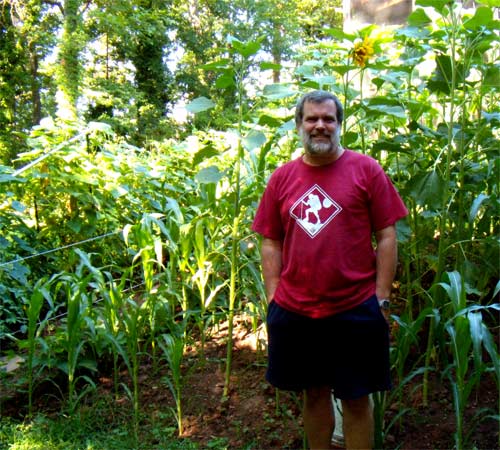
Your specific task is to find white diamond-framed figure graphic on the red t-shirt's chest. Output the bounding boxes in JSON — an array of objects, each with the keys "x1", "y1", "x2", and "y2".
[{"x1": 290, "y1": 184, "x2": 342, "y2": 238}]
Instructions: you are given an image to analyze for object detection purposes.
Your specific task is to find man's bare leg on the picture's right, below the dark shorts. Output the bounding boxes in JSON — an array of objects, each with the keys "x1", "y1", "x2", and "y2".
[{"x1": 342, "y1": 396, "x2": 374, "y2": 450}]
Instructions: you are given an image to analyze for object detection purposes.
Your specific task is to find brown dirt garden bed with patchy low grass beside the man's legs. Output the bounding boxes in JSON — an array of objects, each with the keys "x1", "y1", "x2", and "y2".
[{"x1": 0, "y1": 314, "x2": 498, "y2": 449}]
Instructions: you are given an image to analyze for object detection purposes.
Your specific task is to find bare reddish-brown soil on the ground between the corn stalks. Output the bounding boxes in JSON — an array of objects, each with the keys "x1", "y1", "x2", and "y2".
[{"x1": 3, "y1": 318, "x2": 499, "y2": 450}]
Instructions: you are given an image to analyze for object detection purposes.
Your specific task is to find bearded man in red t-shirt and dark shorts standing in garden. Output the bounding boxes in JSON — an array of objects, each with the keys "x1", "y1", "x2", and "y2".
[{"x1": 252, "y1": 91, "x2": 408, "y2": 449}]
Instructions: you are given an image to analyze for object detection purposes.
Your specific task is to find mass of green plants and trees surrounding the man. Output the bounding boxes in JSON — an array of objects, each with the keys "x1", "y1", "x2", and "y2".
[{"x1": 0, "y1": 0, "x2": 500, "y2": 448}]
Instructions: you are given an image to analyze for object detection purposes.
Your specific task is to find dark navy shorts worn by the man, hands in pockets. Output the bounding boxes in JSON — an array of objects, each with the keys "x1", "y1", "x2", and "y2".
[{"x1": 266, "y1": 296, "x2": 391, "y2": 400}]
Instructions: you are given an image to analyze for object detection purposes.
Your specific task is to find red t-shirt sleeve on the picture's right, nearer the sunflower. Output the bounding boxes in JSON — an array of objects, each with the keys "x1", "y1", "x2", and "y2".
[{"x1": 370, "y1": 166, "x2": 408, "y2": 231}]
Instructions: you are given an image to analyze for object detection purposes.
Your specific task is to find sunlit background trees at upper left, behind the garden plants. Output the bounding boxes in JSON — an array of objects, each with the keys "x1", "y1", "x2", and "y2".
[{"x1": 0, "y1": 0, "x2": 342, "y2": 155}]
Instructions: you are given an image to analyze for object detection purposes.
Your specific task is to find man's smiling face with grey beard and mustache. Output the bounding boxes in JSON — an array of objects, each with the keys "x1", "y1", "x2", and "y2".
[{"x1": 299, "y1": 100, "x2": 340, "y2": 155}]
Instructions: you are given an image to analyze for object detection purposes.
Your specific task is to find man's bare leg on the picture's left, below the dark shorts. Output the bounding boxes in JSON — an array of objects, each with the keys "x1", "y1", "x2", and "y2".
[{"x1": 303, "y1": 386, "x2": 334, "y2": 449}]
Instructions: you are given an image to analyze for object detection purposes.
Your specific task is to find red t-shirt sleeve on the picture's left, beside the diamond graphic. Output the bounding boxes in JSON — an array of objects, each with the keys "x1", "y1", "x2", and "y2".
[{"x1": 252, "y1": 177, "x2": 285, "y2": 241}]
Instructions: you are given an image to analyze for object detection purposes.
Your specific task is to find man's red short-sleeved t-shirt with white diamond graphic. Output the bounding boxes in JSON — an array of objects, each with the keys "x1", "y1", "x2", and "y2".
[{"x1": 252, "y1": 150, "x2": 408, "y2": 318}]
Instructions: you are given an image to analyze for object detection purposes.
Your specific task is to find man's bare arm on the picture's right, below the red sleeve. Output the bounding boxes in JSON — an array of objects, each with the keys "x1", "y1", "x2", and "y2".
[{"x1": 375, "y1": 225, "x2": 398, "y2": 300}]
